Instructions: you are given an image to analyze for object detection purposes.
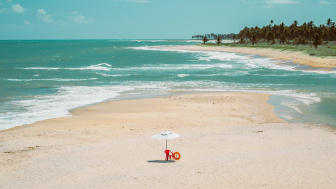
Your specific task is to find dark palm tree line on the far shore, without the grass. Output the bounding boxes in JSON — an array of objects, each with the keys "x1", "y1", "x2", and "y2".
[{"x1": 201, "y1": 18, "x2": 336, "y2": 48}]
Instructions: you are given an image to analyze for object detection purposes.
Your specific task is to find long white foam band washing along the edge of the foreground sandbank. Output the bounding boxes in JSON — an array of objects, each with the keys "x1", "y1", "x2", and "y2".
[{"x1": 0, "y1": 79, "x2": 321, "y2": 130}]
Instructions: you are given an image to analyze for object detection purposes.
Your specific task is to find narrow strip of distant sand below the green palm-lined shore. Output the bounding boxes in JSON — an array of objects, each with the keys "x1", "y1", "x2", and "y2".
[{"x1": 161, "y1": 45, "x2": 336, "y2": 68}]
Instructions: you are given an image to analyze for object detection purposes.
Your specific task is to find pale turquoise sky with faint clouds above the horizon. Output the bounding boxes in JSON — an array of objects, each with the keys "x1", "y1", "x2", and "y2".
[{"x1": 0, "y1": 0, "x2": 336, "y2": 40}]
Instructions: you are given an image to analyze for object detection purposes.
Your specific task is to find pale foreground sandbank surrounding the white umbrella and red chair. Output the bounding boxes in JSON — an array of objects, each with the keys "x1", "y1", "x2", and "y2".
[{"x1": 0, "y1": 93, "x2": 336, "y2": 189}]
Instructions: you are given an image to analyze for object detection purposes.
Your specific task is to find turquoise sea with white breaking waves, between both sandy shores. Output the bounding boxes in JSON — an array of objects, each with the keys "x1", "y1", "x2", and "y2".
[{"x1": 0, "y1": 40, "x2": 336, "y2": 130}]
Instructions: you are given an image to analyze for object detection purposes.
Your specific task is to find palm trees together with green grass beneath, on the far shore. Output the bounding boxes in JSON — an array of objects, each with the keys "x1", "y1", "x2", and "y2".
[{"x1": 198, "y1": 18, "x2": 336, "y2": 57}]
